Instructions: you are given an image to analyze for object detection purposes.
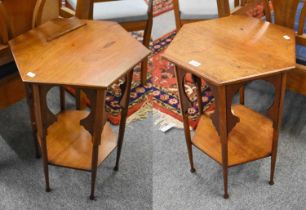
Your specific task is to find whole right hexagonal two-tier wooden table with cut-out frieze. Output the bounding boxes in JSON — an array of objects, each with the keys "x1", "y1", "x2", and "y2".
[{"x1": 164, "y1": 16, "x2": 295, "y2": 198}]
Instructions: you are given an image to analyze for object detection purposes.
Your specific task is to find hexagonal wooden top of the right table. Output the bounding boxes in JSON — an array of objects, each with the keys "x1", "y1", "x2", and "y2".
[{"x1": 164, "y1": 15, "x2": 296, "y2": 85}]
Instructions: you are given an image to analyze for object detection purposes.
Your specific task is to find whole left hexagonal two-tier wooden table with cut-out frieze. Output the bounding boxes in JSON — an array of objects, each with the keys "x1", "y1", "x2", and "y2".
[{"x1": 9, "y1": 18, "x2": 149, "y2": 199}]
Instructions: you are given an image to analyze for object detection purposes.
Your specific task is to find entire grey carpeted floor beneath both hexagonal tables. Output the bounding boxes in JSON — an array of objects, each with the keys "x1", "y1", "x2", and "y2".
[{"x1": 0, "y1": 8, "x2": 306, "y2": 210}]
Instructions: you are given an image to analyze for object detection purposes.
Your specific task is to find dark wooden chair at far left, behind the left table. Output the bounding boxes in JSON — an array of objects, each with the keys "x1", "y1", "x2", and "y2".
[{"x1": 0, "y1": 0, "x2": 56, "y2": 157}]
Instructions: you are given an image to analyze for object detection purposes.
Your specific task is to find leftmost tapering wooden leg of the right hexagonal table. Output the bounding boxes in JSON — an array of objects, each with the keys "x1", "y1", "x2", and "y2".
[{"x1": 175, "y1": 66, "x2": 195, "y2": 173}]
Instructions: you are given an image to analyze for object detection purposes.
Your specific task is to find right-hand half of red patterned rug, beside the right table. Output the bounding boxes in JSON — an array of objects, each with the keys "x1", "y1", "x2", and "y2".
[{"x1": 151, "y1": 31, "x2": 213, "y2": 128}]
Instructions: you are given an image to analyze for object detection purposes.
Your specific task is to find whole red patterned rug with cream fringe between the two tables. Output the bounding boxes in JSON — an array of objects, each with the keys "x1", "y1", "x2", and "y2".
[{"x1": 65, "y1": 1, "x2": 262, "y2": 128}]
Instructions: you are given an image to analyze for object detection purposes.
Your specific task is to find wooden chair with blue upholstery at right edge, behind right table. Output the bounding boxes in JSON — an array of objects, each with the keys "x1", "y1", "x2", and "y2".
[{"x1": 264, "y1": 0, "x2": 306, "y2": 95}]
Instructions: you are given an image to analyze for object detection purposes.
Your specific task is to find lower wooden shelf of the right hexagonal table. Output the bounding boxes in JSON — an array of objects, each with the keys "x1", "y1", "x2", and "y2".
[{"x1": 192, "y1": 105, "x2": 273, "y2": 167}]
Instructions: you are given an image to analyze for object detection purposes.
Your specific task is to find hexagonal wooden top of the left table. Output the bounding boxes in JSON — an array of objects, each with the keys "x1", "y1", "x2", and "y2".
[{"x1": 9, "y1": 18, "x2": 150, "y2": 88}]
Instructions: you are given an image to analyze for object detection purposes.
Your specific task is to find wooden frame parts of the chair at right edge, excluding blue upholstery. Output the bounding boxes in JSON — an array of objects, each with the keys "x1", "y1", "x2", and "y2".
[{"x1": 264, "y1": 0, "x2": 306, "y2": 95}]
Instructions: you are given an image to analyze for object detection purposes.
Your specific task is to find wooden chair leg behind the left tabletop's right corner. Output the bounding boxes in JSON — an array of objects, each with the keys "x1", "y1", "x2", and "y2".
[{"x1": 141, "y1": 17, "x2": 153, "y2": 85}]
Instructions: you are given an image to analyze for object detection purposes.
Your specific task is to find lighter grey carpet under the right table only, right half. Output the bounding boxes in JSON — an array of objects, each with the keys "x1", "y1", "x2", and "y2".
[{"x1": 153, "y1": 82, "x2": 306, "y2": 210}]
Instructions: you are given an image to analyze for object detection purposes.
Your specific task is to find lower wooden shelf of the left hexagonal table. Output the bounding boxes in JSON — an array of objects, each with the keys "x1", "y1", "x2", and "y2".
[{"x1": 42, "y1": 111, "x2": 117, "y2": 170}]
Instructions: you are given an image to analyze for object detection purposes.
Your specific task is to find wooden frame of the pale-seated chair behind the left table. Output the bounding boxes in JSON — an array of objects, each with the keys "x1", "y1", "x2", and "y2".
[{"x1": 60, "y1": 0, "x2": 153, "y2": 85}]
